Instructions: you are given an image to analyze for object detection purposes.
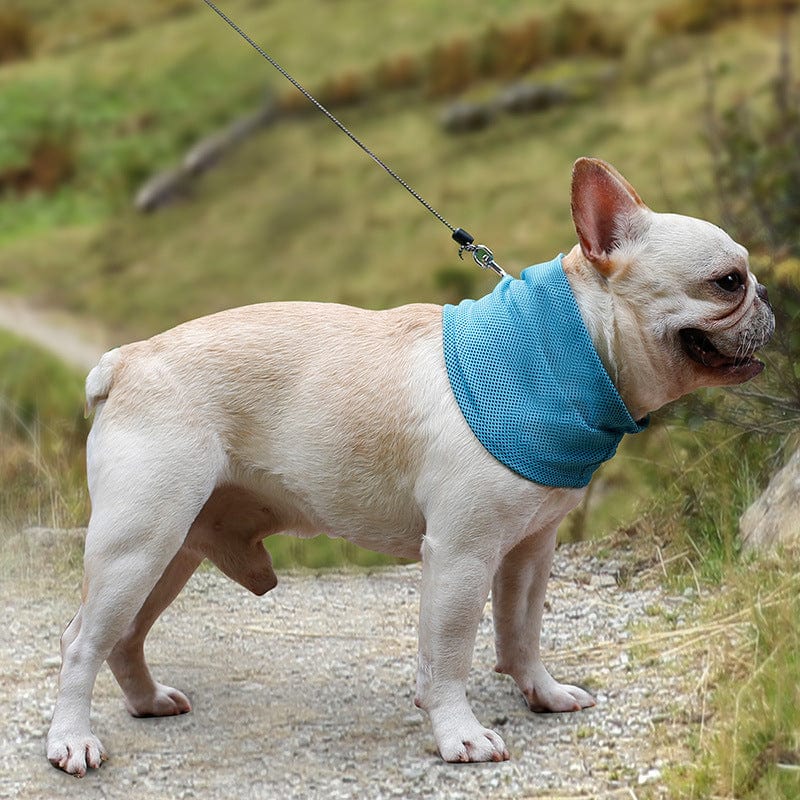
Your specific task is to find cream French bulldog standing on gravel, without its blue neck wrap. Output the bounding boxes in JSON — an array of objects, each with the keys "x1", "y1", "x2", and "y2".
[{"x1": 47, "y1": 159, "x2": 774, "y2": 776}]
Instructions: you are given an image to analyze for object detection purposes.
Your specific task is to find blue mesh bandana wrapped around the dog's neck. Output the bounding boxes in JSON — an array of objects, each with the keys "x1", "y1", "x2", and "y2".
[{"x1": 442, "y1": 256, "x2": 649, "y2": 487}]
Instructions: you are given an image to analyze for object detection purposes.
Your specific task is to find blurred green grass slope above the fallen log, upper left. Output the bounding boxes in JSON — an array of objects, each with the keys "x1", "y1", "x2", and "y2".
[{"x1": 0, "y1": 0, "x2": 648, "y2": 237}]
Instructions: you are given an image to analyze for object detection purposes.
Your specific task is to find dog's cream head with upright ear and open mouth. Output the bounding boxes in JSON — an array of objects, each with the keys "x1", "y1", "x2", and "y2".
[{"x1": 571, "y1": 158, "x2": 775, "y2": 412}]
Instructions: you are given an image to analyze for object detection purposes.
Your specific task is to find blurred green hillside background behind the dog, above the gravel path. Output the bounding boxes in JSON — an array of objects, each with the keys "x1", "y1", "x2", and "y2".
[{"x1": 0, "y1": 0, "x2": 800, "y2": 566}]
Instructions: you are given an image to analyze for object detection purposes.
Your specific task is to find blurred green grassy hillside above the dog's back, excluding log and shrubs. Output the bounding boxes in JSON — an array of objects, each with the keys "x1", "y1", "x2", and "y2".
[{"x1": 0, "y1": 0, "x2": 792, "y2": 338}]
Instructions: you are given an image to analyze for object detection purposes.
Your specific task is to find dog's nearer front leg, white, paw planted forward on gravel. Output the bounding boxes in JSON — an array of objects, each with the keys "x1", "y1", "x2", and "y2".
[{"x1": 415, "y1": 536, "x2": 509, "y2": 761}]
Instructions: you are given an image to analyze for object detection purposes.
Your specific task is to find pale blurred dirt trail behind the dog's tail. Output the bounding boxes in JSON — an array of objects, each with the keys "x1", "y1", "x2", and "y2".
[{"x1": 0, "y1": 294, "x2": 109, "y2": 372}]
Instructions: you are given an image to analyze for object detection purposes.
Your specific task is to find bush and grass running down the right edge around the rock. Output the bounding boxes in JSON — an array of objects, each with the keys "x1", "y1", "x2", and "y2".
[{"x1": 640, "y1": 21, "x2": 800, "y2": 800}]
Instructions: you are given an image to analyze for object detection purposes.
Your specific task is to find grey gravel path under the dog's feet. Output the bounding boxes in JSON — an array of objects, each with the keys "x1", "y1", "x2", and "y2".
[{"x1": 0, "y1": 546, "x2": 702, "y2": 800}]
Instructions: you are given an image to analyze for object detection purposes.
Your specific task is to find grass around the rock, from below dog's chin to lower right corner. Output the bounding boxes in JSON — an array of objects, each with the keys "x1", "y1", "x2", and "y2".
[{"x1": 625, "y1": 416, "x2": 800, "y2": 800}]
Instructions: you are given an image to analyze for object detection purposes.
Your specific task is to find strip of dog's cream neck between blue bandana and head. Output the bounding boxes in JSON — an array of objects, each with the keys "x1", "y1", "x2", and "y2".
[{"x1": 562, "y1": 245, "x2": 675, "y2": 419}]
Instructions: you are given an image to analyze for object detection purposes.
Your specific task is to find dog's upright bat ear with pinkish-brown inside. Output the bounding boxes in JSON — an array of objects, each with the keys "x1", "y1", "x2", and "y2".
[{"x1": 572, "y1": 158, "x2": 647, "y2": 276}]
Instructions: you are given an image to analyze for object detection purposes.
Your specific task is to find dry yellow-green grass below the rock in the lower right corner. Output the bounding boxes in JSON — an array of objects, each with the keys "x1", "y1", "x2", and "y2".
[{"x1": 668, "y1": 552, "x2": 800, "y2": 800}]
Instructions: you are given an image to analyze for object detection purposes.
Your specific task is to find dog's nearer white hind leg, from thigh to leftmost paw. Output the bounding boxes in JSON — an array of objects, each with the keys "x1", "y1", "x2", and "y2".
[{"x1": 47, "y1": 421, "x2": 222, "y2": 776}]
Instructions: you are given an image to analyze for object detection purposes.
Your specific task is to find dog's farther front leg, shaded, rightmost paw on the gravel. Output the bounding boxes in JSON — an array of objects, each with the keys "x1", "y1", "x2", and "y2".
[{"x1": 492, "y1": 526, "x2": 595, "y2": 711}]
